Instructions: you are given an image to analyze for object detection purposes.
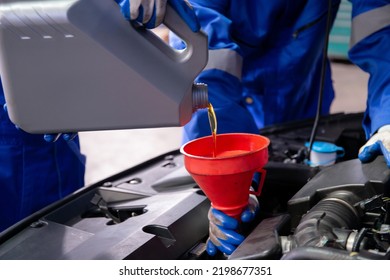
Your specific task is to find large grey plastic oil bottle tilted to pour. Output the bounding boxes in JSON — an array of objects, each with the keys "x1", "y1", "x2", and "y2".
[{"x1": 0, "y1": 0, "x2": 208, "y2": 133}]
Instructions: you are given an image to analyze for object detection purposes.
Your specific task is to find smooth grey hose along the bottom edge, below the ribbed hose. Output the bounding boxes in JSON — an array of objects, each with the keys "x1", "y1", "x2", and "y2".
[{"x1": 281, "y1": 247, "x2": 386, "y2": 260}]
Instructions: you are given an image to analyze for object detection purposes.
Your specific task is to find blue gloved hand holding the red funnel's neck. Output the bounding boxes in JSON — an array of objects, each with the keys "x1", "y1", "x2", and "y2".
[{"x1": 206, "y1": 194, "x2": 259, "y2": 256}]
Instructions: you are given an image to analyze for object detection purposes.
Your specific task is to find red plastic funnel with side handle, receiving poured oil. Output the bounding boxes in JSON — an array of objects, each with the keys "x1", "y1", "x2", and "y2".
[{"x1": 180, "y1": 133, "x2": 270, "y2": 220}]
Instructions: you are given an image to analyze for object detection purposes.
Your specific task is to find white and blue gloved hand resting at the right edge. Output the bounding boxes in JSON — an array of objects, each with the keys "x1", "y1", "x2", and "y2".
[{"x1": 359, "y1": 125, "x2": 390, "y2": 168}]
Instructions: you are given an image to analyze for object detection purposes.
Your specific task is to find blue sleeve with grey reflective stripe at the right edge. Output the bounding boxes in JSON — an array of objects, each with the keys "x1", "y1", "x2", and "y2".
[{"x1": 349, "y1": 0, "x2": 390, "y2": 138}]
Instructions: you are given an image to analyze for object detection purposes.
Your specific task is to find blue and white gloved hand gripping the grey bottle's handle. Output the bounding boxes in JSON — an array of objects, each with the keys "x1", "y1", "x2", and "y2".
[{"x1": 115, "y1": 0, "x2": 200, "y2": 32}]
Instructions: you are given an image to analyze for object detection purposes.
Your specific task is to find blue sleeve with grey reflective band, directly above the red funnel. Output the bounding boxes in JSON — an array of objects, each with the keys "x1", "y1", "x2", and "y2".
[{"x1": 171, "y1": 0, "x2": 258, "y2": 142}]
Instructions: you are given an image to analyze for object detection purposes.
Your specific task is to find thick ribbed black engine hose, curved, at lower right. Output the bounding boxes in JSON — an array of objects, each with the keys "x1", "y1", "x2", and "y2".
[{"x1": 293, "y1": 198, "x2": 360, "y2": 247}]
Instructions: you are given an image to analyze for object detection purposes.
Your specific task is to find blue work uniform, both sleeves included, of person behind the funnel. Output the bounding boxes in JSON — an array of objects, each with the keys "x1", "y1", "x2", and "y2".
[{"x1": 178, "y1": 0, "x2": 390, "y2": 142}]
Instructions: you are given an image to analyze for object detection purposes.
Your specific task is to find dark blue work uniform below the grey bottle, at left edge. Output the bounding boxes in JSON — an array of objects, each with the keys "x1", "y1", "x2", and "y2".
[{"x1": 0, "y1": 81, "x2": 85, "y2": 232}]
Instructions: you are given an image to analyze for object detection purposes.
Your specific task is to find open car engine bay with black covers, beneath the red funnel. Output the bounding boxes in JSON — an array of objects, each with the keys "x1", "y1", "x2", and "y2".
[{"x1": 0, "y1": 113, "x2": 390, "y2": 260}]
